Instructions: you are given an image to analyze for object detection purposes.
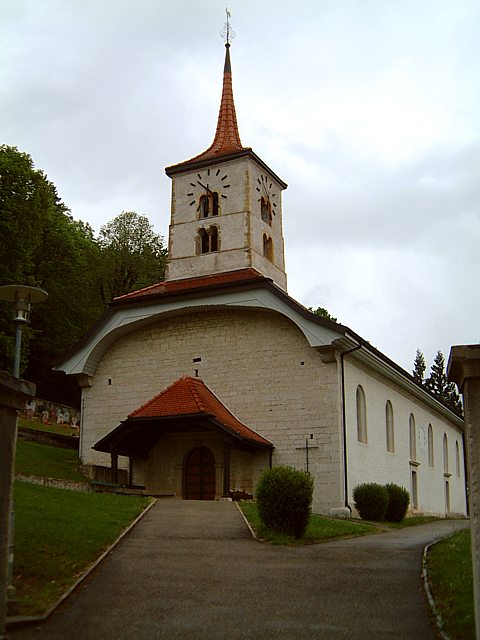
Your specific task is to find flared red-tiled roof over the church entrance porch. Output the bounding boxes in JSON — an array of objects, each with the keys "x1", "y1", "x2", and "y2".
[{"x1": 128, "y1": 376, "x2": 273, "y2": 447}]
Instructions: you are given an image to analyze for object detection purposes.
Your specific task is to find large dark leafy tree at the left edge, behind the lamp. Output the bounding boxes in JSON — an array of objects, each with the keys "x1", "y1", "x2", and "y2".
[{"x1": 0, "y1": 145, "x2": 102, "y2": 399}]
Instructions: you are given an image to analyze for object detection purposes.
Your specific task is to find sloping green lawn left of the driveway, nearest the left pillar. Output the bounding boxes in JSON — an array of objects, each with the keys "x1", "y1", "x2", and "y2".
[{"x1": 14, "y1": 481, "x2": 151, "y2": 615}]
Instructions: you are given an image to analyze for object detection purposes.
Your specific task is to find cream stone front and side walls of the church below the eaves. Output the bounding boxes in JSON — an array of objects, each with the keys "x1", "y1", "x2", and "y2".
[{"x1": 71, "y1": 303, "x2": 466, "y2": 515}]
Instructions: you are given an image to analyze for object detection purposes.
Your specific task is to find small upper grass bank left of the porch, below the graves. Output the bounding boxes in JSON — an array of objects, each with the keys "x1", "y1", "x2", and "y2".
[{"x1": 15, "y1": 440, "x2": 85, "y2": 481}]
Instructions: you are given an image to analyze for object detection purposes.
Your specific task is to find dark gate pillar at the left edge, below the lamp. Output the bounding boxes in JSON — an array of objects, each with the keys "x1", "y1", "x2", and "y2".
[{"x1": 0, "y1": 371, "x2": 35, "y2": 638}]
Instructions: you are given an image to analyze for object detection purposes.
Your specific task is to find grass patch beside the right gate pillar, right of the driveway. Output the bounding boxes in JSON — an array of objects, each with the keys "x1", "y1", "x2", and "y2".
[{"x1": 428, "y1": 529, "x2": 475, "y2": 640}]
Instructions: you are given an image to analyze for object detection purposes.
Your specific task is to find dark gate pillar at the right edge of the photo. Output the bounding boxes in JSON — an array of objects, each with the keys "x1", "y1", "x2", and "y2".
[{"x1": 447, "y1": 344, "x2": 480, "y2": 640}]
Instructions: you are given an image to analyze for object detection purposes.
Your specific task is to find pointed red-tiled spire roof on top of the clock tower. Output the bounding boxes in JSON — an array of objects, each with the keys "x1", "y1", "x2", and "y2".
[{"x1": 166, "y1": 42, "x2": 251, "y2": 174}]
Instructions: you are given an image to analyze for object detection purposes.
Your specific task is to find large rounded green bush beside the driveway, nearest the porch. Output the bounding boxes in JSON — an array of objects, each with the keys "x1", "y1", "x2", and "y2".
[{"x1": 256, "y1": 466, "x2": 313, "y2": 538}]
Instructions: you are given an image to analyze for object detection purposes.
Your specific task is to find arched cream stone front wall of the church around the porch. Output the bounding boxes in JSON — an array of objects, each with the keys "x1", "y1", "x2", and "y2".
[{"x1": 80, "y1": 308, "x2": 343, "y2": 512}]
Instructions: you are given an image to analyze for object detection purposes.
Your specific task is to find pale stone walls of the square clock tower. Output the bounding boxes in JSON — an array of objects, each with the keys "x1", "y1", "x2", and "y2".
[{"x1": 166, "y1": 157, "x2": 287, "y2": 290}]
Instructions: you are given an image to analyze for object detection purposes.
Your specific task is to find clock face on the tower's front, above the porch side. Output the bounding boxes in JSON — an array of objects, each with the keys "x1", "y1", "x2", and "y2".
[{"x1": 187, "y1": 167, "x2": 230, "y2": 218}]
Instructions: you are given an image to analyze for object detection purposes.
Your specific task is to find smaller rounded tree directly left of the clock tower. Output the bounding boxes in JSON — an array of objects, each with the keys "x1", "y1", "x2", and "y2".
[{"x1": 98, "y1": 211, "x2": 167, "y2": 304}]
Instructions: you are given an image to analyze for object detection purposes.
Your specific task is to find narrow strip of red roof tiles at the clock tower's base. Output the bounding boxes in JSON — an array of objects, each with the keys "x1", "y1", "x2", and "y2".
[{"x1": 114, "y1": 269, "x2": 265, "y2": 302}]
